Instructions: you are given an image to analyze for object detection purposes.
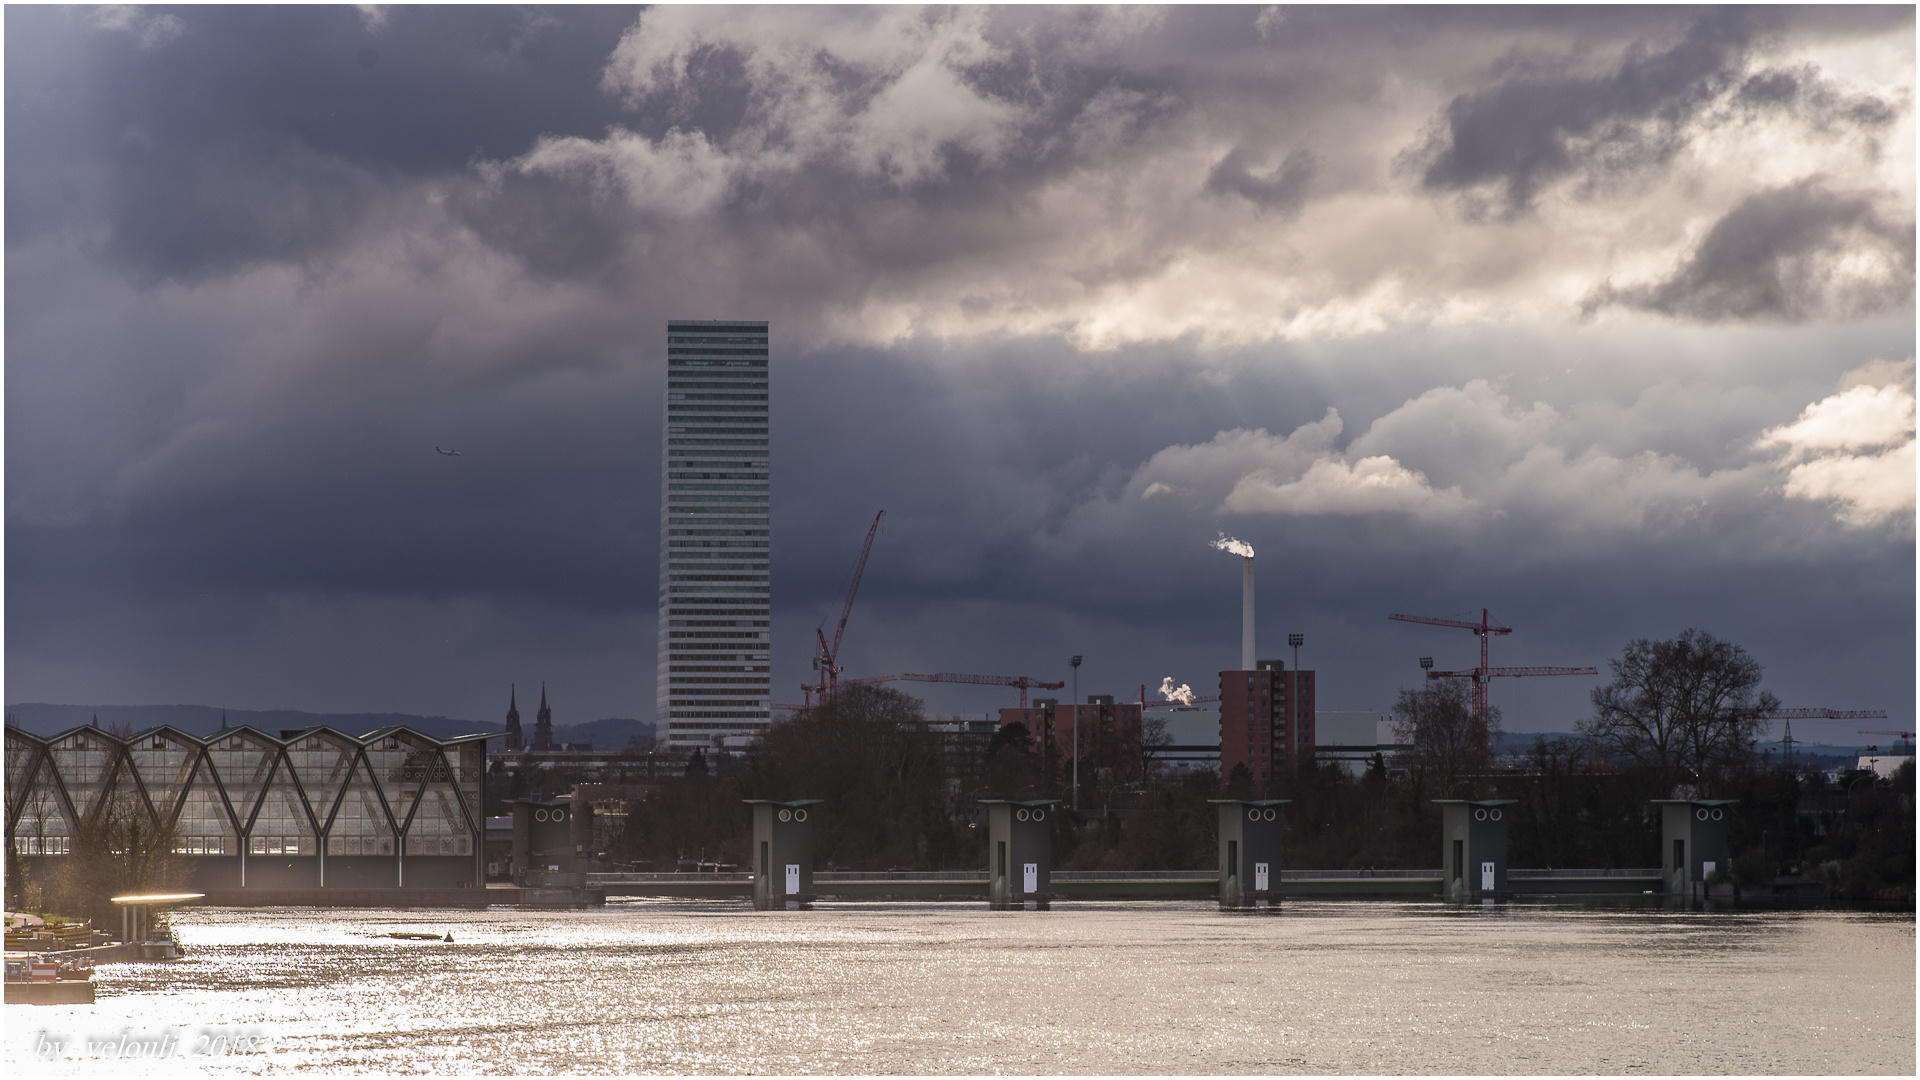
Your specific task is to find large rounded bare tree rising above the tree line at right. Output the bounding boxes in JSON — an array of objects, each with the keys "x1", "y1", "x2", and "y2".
[{"x1": 1580, "y1": 628, "x2": 1780, "y2": 792}]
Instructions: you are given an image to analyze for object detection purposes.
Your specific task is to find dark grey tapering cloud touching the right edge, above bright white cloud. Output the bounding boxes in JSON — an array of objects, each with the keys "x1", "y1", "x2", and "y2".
[{"x1": 1582, "y1": 177, "x2": 1914, "y2": 323}]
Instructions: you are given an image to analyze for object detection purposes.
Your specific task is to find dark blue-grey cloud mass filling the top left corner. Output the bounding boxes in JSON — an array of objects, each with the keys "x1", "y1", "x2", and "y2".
[{"x1": 6, "y1": 6, "x2": 634, "y2": 279}]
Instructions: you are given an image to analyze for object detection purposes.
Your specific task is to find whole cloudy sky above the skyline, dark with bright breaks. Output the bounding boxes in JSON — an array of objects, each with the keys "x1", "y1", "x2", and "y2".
[{"x1": 6, "y1": 6, "x2": 1914, "y2": 738}]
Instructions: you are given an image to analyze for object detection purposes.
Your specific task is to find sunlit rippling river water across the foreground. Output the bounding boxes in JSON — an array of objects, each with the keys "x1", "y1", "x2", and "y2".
[{"x1": 6, "y1": 901, "x2": 1914, "y2": 1074}]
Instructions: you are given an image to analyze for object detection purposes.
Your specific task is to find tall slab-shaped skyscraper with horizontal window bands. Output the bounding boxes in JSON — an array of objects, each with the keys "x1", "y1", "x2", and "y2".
[{"x1": 657, "y1": 321, "x2": 772, "y2": 751}]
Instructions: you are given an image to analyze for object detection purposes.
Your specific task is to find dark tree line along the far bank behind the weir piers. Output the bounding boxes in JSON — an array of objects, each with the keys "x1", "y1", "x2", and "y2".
[{"x1": 612, "y1": 630, "x2": 1914, "y2": 903}]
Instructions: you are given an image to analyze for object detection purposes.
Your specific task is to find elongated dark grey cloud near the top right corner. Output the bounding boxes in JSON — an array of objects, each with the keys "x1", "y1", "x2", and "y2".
[{"x1": 1404, "y1": 8, "x2": 1897, "y2": 211}]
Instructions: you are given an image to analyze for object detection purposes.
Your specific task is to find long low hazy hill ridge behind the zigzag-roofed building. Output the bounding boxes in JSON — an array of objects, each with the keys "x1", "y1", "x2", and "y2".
[{"x1": 6, "y1": 701, "x2": 653, "y2": 749}]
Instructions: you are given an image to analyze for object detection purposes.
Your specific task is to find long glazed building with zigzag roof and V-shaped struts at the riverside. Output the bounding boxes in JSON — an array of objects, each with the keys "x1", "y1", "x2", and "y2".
[{"x1": 6, "y1": 724, "x2": 499, "y2": 890}]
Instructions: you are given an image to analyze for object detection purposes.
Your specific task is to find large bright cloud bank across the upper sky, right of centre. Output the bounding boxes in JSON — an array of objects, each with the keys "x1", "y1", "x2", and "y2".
[{"x1": 460, "y1": 6, "x2": 1912, "y2": 349}]
